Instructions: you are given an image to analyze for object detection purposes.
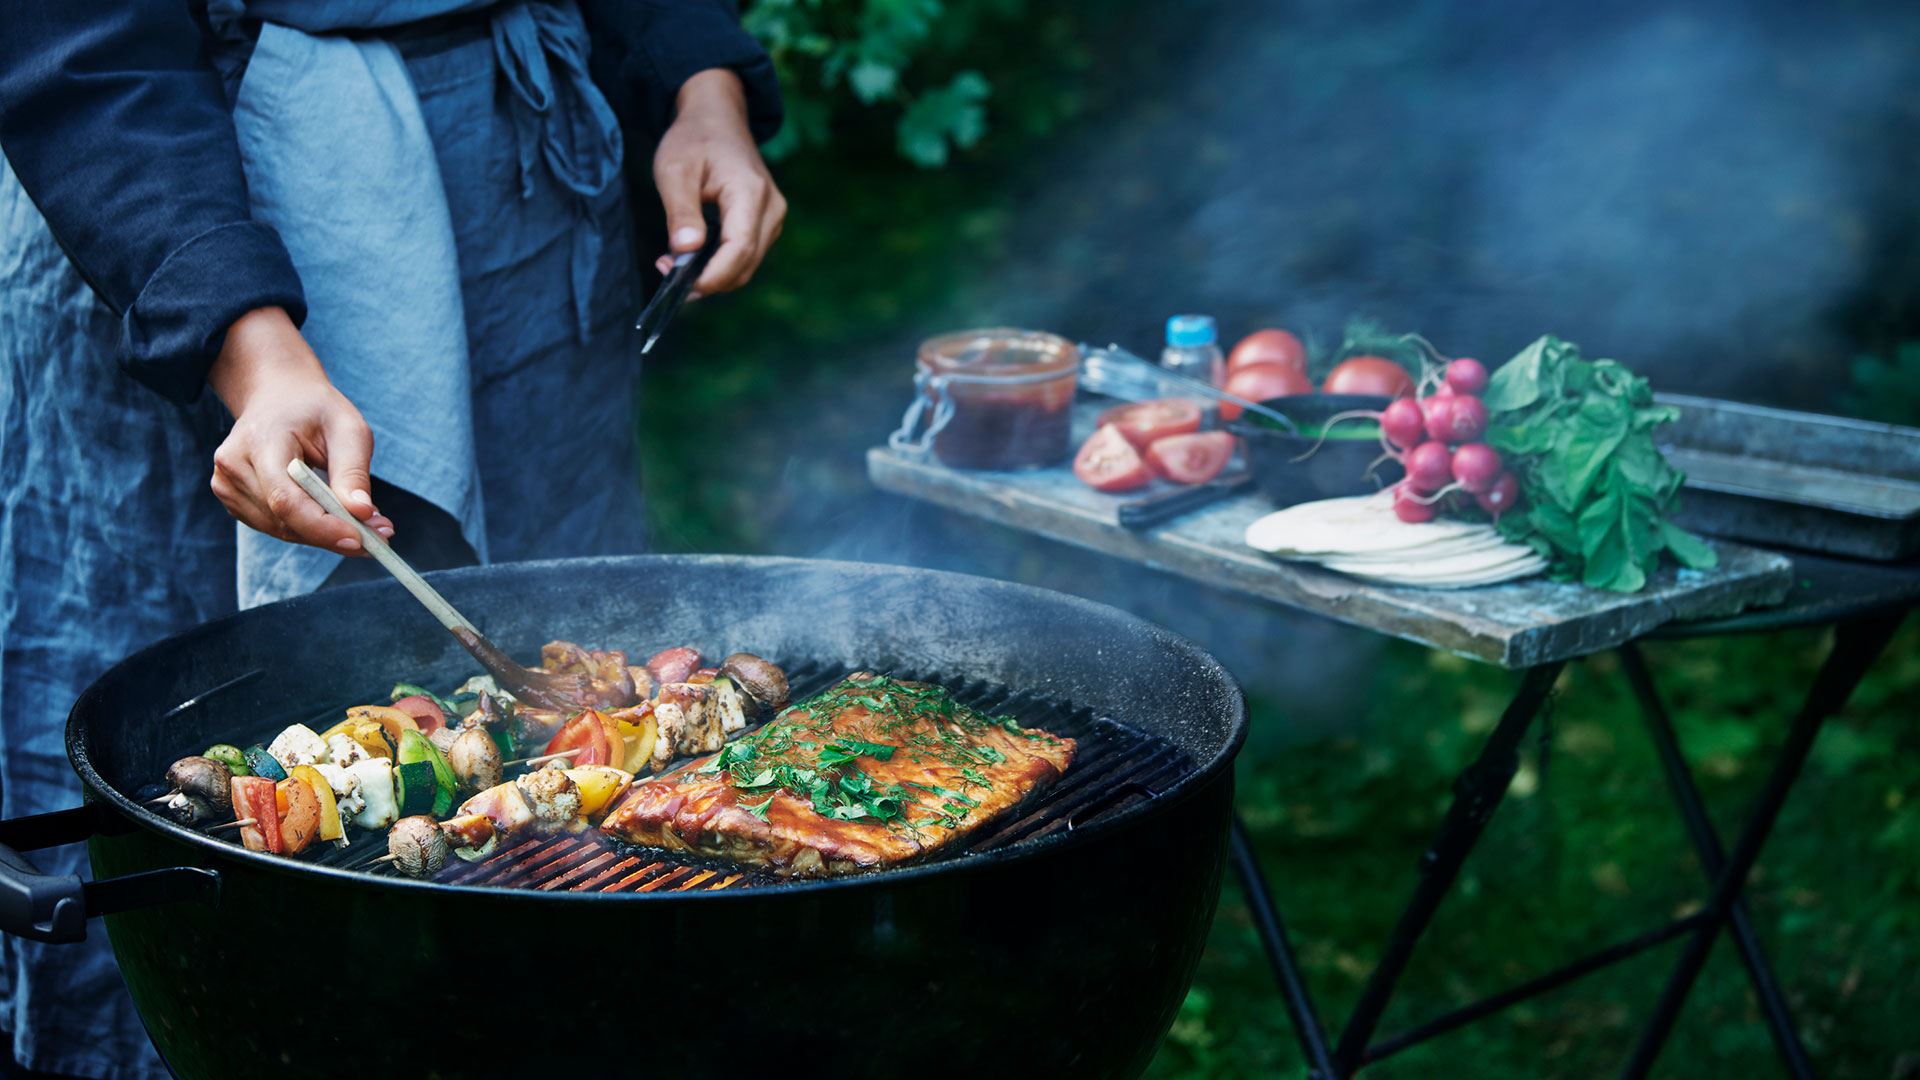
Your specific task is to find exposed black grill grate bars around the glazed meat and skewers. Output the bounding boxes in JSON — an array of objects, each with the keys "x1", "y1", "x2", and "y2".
[{"x1": 198, "y1": 663, "x2": 1192, "y2": 892}]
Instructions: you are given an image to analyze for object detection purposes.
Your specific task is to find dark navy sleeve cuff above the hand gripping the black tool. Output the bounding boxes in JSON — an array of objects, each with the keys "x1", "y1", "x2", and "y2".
[{"x1": 580, "y1": 0, "x2": 783, "y2": 142}]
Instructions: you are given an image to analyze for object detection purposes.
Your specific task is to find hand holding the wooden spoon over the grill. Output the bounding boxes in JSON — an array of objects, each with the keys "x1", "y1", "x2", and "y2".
[{"x1": 207, "y1": 307, "x2": 394, "y2": 555}]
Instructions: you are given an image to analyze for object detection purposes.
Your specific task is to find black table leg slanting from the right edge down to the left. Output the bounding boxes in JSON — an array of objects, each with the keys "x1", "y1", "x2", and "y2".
[{"x1": 1620, "y1": 611, "x2": 1905, "y2": 1076}]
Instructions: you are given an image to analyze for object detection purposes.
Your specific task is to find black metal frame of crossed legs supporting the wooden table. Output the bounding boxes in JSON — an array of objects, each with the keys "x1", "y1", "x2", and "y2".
[{"x1": 1233, "y1": 559, "x2": 1920, "y2": 1080}]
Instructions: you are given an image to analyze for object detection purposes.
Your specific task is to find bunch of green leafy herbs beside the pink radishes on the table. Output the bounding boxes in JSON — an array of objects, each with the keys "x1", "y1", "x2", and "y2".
[{"x1": 1482, "y1": 334, "x2": 1716, "y2": 592}]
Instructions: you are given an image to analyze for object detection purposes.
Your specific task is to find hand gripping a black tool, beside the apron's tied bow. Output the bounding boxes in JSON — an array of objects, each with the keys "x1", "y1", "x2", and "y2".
[{"x1": 653, "y1": 67, "x2": 787, "y2": 296}]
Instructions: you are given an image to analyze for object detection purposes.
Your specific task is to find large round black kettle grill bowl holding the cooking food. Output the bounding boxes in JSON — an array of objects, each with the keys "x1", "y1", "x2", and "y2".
[{"x1": 67, "y1": 557, "x2": 1246, "y2": 1076}]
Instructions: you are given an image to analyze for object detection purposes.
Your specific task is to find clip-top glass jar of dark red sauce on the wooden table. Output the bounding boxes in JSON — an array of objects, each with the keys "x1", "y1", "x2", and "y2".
[{"x1": 889, "y1": 327, "x2": 1079, "y2": 469}]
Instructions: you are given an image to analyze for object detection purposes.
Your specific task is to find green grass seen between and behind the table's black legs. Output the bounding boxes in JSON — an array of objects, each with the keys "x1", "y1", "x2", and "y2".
[{"x1": 1150, "y1": 625, "x2": 1920, "y2": 1080}]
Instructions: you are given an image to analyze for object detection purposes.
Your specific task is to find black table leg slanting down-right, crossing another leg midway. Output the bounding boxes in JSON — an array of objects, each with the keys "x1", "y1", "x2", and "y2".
[{"x1": 1620, "y1": 644, "x2": 1814, "y2": 1080}]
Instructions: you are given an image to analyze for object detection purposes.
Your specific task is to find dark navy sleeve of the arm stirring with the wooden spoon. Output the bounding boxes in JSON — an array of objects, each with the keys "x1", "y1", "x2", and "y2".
[{"x1": 0, "y1": 0, "x2": 305, "y2": 402}]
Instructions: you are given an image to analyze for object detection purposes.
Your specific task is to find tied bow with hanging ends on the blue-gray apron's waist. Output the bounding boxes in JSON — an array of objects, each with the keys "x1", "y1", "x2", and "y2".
[{"x1": 493, "y1": 0, "x2": 622, "y2": 342}]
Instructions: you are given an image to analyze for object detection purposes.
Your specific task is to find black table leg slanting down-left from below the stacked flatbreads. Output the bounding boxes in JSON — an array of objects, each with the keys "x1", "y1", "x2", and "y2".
[{"x1": 1334, "y1": 661, "x2": 1567, "y2": 1076}]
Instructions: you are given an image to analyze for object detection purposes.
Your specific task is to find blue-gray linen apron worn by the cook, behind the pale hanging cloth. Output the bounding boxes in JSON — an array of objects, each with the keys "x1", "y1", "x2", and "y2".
[{"x1": 0, "y1": 6, "x2": 643, "y2": 1078}]
